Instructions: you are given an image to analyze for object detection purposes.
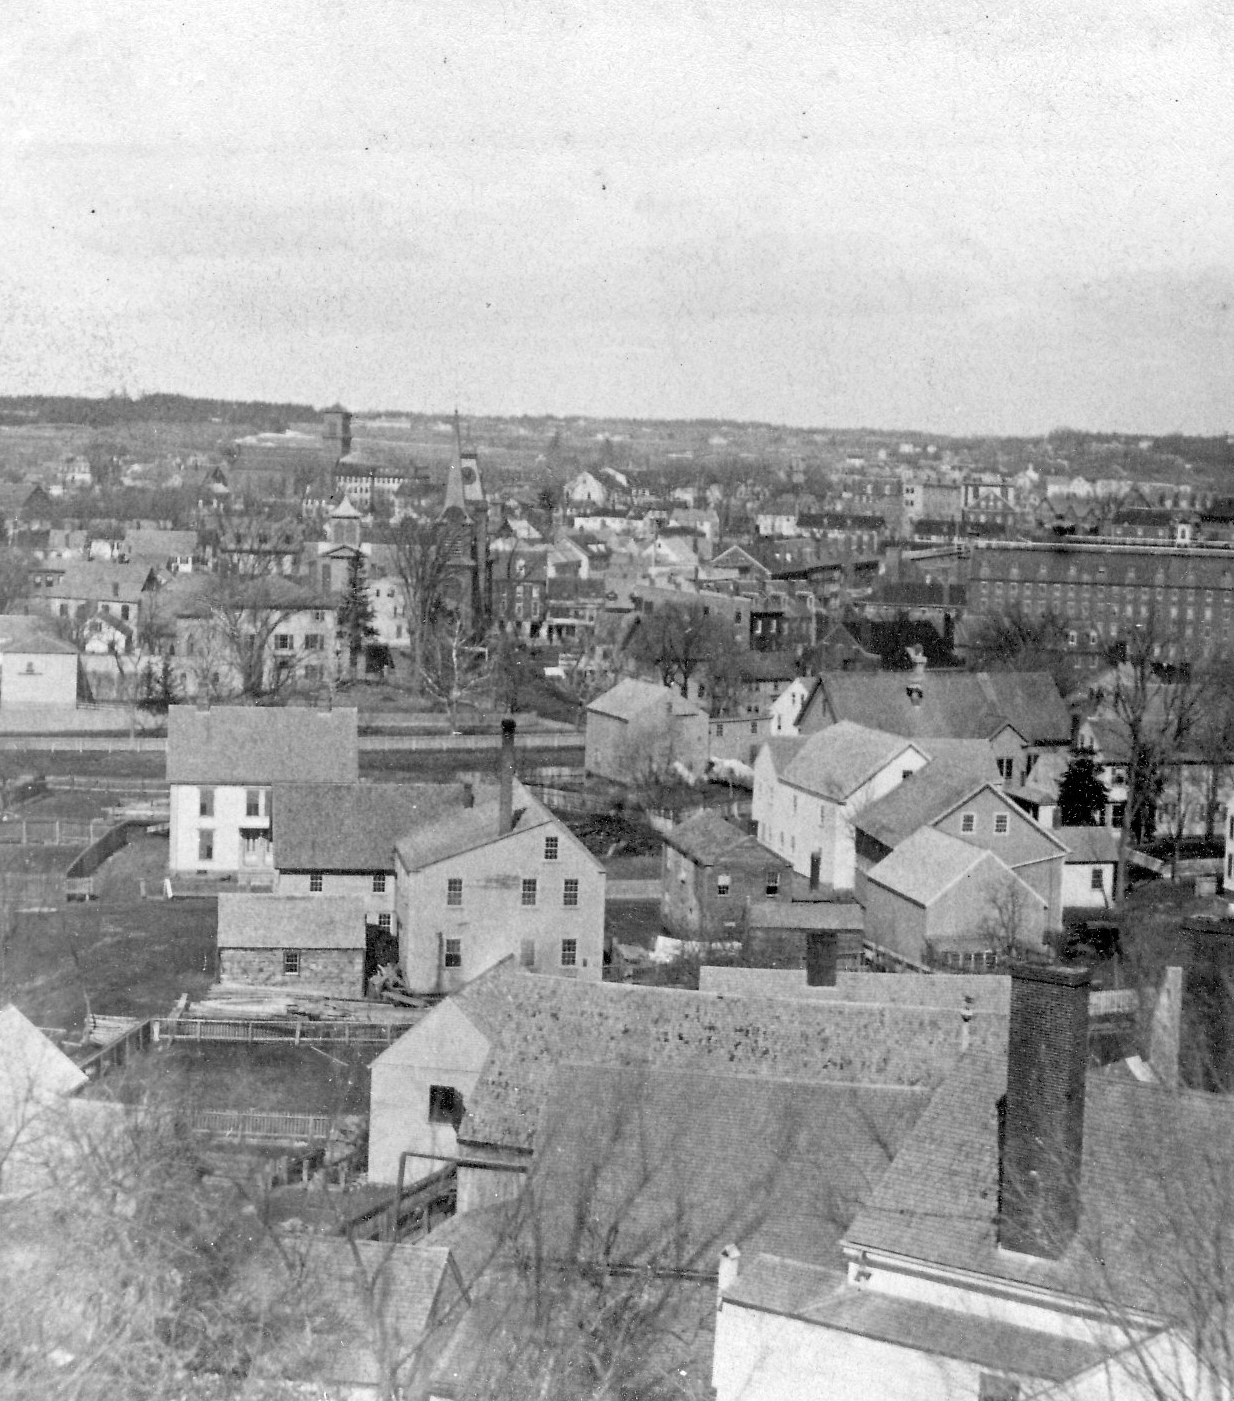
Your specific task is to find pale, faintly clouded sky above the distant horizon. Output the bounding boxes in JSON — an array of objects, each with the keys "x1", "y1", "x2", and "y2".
[{"x1": 0, "y1": 0, "x2": 1234, "y2": 434}]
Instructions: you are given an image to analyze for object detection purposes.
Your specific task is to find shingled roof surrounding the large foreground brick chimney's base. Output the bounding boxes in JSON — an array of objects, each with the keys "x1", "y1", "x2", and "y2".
[{"x1": 847, "y1": 1052, "x2": 1234, "y2": 1325}]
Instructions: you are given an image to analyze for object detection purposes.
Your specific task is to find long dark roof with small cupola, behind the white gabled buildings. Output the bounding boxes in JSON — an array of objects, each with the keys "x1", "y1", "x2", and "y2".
[{"x1": 821, "y1": 671, "x2": 1072, "y2": 744}]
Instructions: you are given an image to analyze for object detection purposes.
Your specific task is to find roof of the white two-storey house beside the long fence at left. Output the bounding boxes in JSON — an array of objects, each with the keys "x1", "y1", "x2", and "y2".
[{"x1": 167, "y1": 705, "x2": 360, "y2": 785}]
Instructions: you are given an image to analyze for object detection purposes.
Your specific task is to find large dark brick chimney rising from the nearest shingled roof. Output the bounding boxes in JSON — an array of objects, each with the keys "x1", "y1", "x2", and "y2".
[{"x1": 999, "y1": 964, "x2": 1088, "y2": 1259}]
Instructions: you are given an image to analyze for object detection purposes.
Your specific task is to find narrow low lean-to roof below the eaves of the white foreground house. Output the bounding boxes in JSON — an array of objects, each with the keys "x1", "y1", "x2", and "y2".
[{"x1": 724, "y1": 1251, "x2": 1105, "y2": 1381}]
